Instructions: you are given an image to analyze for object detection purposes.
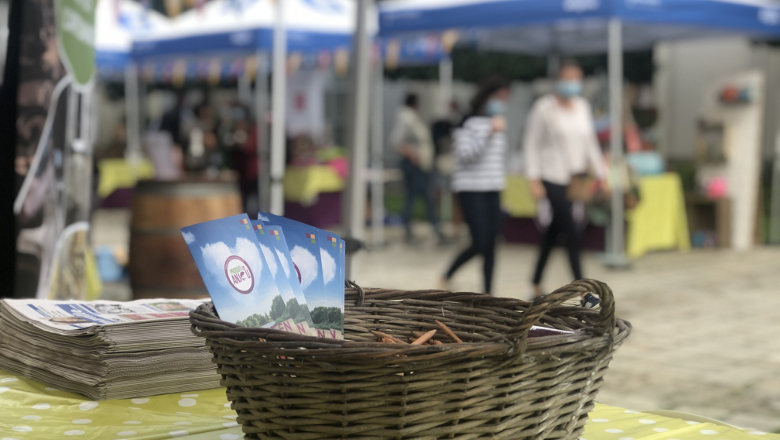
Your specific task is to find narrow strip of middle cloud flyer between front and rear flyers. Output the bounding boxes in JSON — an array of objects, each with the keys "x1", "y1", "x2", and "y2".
[{"x1": 251, "y1": 220, "x2": 316, "y2": 336}]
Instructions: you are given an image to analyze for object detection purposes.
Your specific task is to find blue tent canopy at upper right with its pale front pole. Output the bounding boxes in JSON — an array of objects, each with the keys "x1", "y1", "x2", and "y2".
[{"x1": 379, "y1": 0, "x2": 780, "y2": 266}]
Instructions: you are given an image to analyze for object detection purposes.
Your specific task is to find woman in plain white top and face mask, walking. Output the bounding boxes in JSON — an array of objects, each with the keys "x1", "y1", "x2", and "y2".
[{"x1": 524, "y1": 58, "x2": 606, "y2": 307}]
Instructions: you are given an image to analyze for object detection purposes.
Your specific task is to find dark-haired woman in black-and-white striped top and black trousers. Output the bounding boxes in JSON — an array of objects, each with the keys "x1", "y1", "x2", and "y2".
[{"x1": 442, "y1": 77, "x2": 509, "y2": 293}]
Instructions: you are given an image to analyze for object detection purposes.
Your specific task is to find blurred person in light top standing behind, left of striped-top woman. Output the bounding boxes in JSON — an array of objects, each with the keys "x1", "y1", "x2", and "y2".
[{"x1": 390, "y1": 93, "x2": 444, "y2": 243}]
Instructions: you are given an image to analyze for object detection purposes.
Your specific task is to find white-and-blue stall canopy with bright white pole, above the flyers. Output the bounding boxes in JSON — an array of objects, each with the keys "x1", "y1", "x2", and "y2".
[{"x1": 128, "y1": 0, "x2": 368, "y2": 213}]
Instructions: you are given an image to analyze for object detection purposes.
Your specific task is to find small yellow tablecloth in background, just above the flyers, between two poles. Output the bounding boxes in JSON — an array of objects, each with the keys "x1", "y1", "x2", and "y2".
[{"x1": 284, "y1": 165, "x2": 344, "y2": 205}]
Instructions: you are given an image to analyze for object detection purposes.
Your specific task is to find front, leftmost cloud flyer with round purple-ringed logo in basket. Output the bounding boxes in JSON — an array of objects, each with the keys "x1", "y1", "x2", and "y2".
[{"x1": 181, "y1": 214, "x2": 289, "y2": 328}]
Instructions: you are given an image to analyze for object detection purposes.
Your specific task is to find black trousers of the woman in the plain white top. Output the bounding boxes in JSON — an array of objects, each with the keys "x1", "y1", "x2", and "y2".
[{"x1": 533, "y1": 182, "x2": 582, "y2": 285}]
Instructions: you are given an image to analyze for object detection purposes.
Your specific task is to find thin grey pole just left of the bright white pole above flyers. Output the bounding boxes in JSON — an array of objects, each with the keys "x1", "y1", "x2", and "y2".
[{"x1": 254, "y1": 50, "x2": 271, "y2": 212}]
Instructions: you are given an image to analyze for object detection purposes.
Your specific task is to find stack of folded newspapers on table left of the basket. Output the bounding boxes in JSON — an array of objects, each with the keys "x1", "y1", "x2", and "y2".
[{"x1": 0, "y1": 299, "x2": 220, "y2": 400}]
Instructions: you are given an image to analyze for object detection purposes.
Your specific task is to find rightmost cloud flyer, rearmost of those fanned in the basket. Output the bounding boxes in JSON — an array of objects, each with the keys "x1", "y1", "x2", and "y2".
[{"x1": 258, "y1": 212, "x2": 344, "y2": 339}]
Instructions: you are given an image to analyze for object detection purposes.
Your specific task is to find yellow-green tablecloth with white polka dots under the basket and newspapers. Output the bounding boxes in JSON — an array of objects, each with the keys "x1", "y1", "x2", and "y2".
[{"x1": 0, "y1": 370, "x2": 780, "y2": 440}]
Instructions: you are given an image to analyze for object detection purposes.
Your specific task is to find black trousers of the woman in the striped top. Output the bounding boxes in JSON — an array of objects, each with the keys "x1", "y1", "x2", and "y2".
[{"x1": 446, "y1": 191, "x2": 501, "y2": 293}]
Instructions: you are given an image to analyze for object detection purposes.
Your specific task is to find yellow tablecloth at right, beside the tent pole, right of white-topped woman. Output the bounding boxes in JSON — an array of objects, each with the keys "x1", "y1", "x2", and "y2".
[{"x1": 626, "y1": 173, "x2": 691, "y2": 258}]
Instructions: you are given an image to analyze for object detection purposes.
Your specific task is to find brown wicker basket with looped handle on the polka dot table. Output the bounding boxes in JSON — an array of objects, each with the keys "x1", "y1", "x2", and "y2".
[{"x1": 190, "y1": 280, "x2": 631, "y2": 440}]
